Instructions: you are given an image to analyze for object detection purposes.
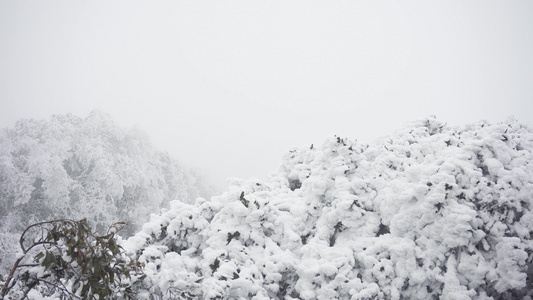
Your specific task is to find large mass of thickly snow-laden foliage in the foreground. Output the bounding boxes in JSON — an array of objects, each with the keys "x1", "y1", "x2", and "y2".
[{"x1": 123, "y1": 118, "x2": 533, "y2": 299}]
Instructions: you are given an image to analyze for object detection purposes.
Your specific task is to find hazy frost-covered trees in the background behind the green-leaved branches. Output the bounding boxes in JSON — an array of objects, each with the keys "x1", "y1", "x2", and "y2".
[{"x1": 0, "y1": 111, "x2": 209, "y2": 269}]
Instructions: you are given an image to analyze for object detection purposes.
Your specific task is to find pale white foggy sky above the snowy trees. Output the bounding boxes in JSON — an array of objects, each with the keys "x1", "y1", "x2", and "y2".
[{"x1": 0, "y1": 0, "x2": 533, "y2": 187}]
